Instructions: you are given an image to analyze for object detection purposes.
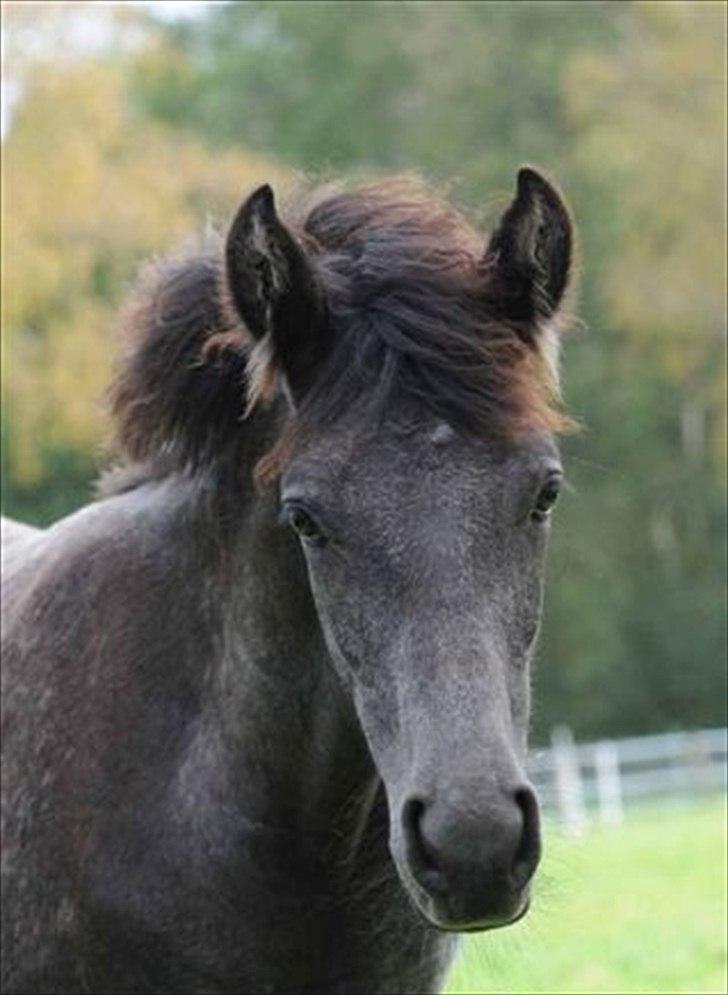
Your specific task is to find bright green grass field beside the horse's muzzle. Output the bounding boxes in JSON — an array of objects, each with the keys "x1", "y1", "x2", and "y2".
[{"x1": 447, "y1": 800, "x2": 728, "y2": 995}]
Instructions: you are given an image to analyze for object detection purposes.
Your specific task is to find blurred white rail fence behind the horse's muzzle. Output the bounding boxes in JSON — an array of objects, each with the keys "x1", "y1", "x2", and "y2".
[{"x1": 529, "y1": 727, "x2": 728, "y2": 834}]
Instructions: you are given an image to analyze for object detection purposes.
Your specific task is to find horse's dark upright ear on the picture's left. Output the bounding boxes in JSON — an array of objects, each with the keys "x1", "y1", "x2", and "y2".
[{"x1": 225, "y1": 184, "x2": 330, "y2": 403}]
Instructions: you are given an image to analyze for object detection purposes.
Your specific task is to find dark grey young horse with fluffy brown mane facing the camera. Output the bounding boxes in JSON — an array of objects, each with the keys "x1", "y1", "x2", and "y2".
[{"x1": 2, "y1": 167, "x2": 573, "y2": 995}]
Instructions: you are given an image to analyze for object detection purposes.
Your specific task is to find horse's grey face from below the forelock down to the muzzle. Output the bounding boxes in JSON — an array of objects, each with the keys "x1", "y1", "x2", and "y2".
[{"x1": 281, "y1": 423, "x2": 561, "y2": 930}]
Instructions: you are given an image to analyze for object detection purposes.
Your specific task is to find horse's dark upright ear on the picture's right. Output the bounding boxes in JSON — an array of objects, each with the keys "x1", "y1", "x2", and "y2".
[{"x1": 484, "y1": 167, "x2": 573, "y2": 338}]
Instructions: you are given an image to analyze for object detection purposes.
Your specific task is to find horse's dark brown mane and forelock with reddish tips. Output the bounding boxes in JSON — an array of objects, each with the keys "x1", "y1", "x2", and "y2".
[{"x1": 104, "y1": 177, "x2": 568, "y2": 496}]
